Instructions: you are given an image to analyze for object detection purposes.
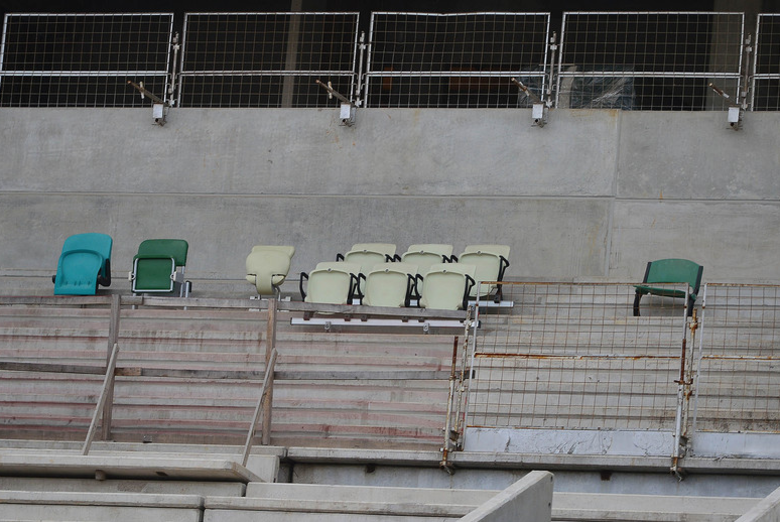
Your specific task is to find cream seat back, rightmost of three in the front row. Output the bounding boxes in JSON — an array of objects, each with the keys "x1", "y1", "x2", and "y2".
[{"x1": 420, "y1": 263, "x2": 477, "y2": 310}]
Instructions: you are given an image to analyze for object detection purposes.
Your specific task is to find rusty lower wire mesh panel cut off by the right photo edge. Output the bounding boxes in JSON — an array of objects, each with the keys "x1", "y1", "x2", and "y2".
[{"x1": 694, "y1": 283, "x2": 780, "y2": 433}]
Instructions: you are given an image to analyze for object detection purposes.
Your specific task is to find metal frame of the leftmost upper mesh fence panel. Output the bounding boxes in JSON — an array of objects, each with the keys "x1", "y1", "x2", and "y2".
[{"x1": 0, "y1": 13, "x2": 174, "y2": 106}]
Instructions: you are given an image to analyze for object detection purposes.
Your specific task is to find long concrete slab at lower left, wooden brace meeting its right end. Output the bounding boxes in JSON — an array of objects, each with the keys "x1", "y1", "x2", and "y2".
[{"x1": 0, "y1": 452, "x2": 264, "y2": 482}]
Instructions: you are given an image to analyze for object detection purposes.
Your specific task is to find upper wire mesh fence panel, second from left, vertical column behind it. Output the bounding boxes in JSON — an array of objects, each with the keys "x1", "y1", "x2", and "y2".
[{"x1": 179, "y1": 13, "x2": 358, "y2": 107}]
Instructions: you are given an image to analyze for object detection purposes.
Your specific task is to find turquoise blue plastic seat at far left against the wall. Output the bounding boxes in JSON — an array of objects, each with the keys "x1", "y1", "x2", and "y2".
[{"x1": 54, "y1": 233, "x2": 114, "y2": 295}]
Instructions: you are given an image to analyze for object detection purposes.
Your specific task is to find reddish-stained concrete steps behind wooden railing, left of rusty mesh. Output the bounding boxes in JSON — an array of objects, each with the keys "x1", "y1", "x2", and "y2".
[{"x1": 0, "y1": 300, "x2": 460, "y2": 448}]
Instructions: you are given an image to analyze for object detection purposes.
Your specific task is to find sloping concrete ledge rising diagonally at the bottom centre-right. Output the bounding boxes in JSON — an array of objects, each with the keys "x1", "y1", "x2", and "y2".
[{"x1": 462, "y1": 471, "x2": 553, "y2": 522}]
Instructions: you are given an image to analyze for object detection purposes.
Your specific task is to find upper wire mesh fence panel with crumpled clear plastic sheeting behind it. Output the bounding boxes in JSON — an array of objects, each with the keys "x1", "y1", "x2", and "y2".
[{"x1": 556, "y1": 12, "x2": 744, "y2": 110}]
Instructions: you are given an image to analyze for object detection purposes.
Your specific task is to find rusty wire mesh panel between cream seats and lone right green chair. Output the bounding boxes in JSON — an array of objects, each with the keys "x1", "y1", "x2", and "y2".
[{"x1": 467, "y1": 283, "x2": 686, "y2": 430}]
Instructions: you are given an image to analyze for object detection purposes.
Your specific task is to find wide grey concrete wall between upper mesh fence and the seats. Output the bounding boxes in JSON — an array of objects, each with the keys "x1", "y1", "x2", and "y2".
[{"x1": 0, "y1": 108, "x2": 780, "y2": 295}]
